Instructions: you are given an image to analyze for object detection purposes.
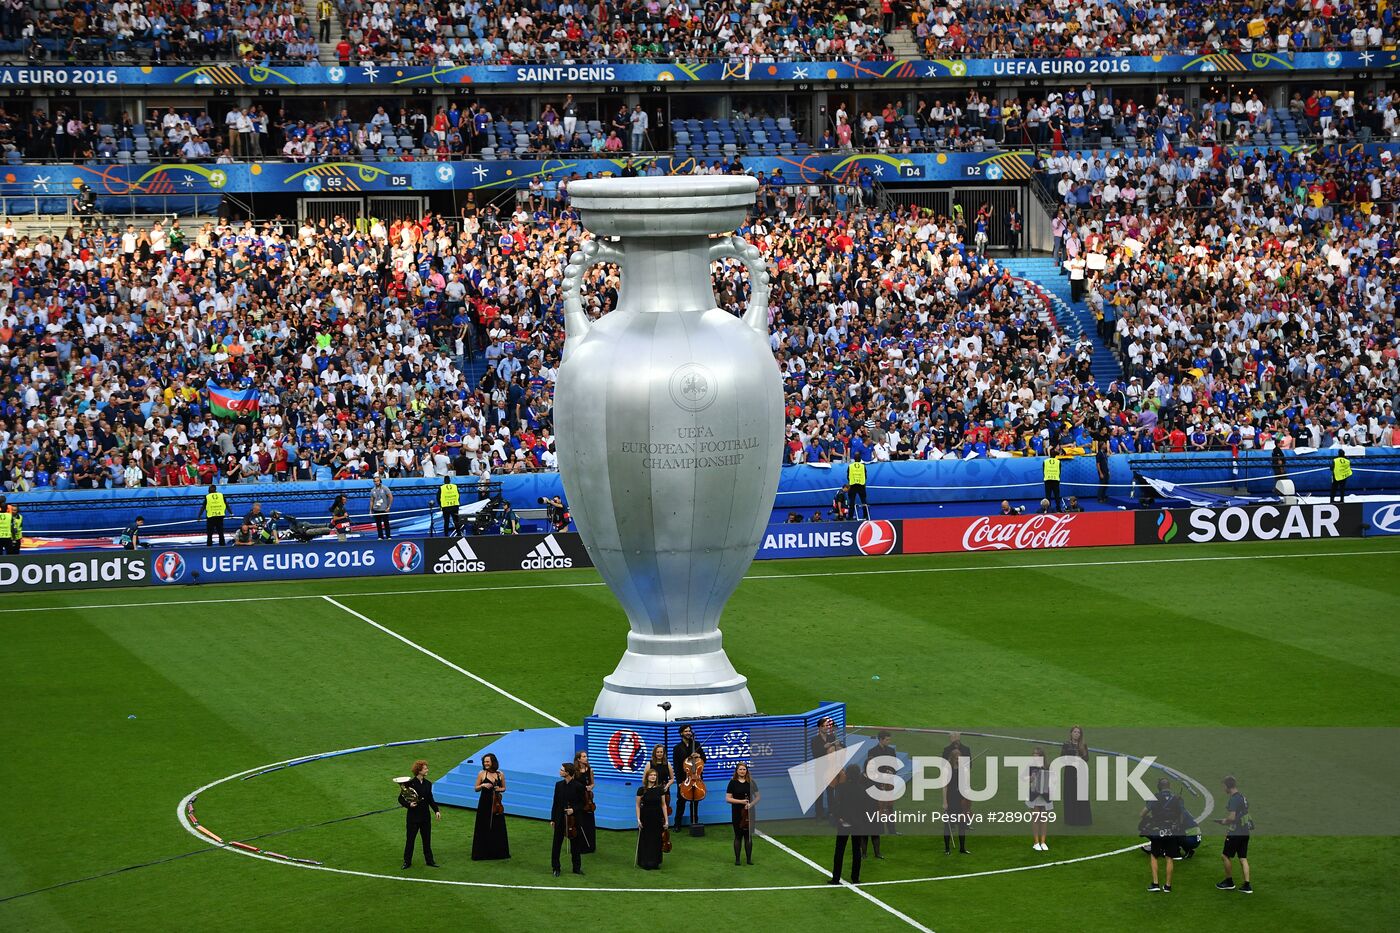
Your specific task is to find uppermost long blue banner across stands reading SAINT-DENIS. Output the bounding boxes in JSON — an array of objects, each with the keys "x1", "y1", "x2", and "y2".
[{"x1": 0, "y1": 52, "x2": 1377, "y2": 86}]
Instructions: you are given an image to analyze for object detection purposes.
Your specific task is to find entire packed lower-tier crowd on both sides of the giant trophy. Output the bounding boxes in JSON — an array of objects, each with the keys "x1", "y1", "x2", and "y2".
[{"x1": 0, "y1": 129, "x2": 1400, "y2": 489}]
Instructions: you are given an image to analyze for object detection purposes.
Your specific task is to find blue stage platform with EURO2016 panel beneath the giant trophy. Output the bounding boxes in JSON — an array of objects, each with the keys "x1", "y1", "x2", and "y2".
[{"x1": 433, "y1": 702, "x2": 845, "y2": 829}]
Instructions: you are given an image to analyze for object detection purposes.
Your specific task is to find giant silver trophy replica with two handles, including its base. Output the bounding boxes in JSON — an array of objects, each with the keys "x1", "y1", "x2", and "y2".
[{"x1": 554, "y1": 177, "x2": 783, "y2": 720}]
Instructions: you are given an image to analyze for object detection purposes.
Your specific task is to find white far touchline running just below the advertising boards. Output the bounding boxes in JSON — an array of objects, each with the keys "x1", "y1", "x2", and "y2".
[{"x1": 0, "y1": 545, "x2": 1400, "y2": 614}]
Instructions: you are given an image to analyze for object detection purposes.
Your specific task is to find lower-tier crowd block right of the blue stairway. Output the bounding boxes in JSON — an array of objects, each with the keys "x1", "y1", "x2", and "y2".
[{"x1": 1047, "y1": 140, "x2": 1400, "y2": 451}]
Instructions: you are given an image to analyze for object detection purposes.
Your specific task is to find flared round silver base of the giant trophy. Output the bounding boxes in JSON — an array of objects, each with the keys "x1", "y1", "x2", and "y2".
[{"x1": 594, "y1": 632, "x2": 757, "y2": 723}]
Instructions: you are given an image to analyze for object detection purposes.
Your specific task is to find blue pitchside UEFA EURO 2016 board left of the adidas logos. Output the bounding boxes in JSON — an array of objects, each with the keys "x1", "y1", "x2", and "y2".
[{"x1": 150, "y1": 539, "x2": 423, "y2": 584}]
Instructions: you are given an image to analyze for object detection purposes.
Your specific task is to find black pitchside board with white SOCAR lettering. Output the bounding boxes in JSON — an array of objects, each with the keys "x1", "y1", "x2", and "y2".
[{"x1": 1134, "y1": 503, "x2": 1361, "y2": 544}]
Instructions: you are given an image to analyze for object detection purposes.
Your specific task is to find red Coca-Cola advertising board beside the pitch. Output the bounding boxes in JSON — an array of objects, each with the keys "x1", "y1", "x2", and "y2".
[{"x1": 903, "y1": 511, "x2": 1133, "y2": 553}]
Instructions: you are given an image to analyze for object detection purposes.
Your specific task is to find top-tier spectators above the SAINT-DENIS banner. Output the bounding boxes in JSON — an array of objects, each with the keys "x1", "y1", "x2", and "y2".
[{"x1": 8, "y1": 0, "x2": 1396, "y2": 66}]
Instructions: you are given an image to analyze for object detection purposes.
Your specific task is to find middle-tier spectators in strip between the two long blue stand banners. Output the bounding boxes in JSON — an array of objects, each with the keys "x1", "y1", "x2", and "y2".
[{"x1": 19, "y1": 84, "x2": 1400, "y2": 164}]
